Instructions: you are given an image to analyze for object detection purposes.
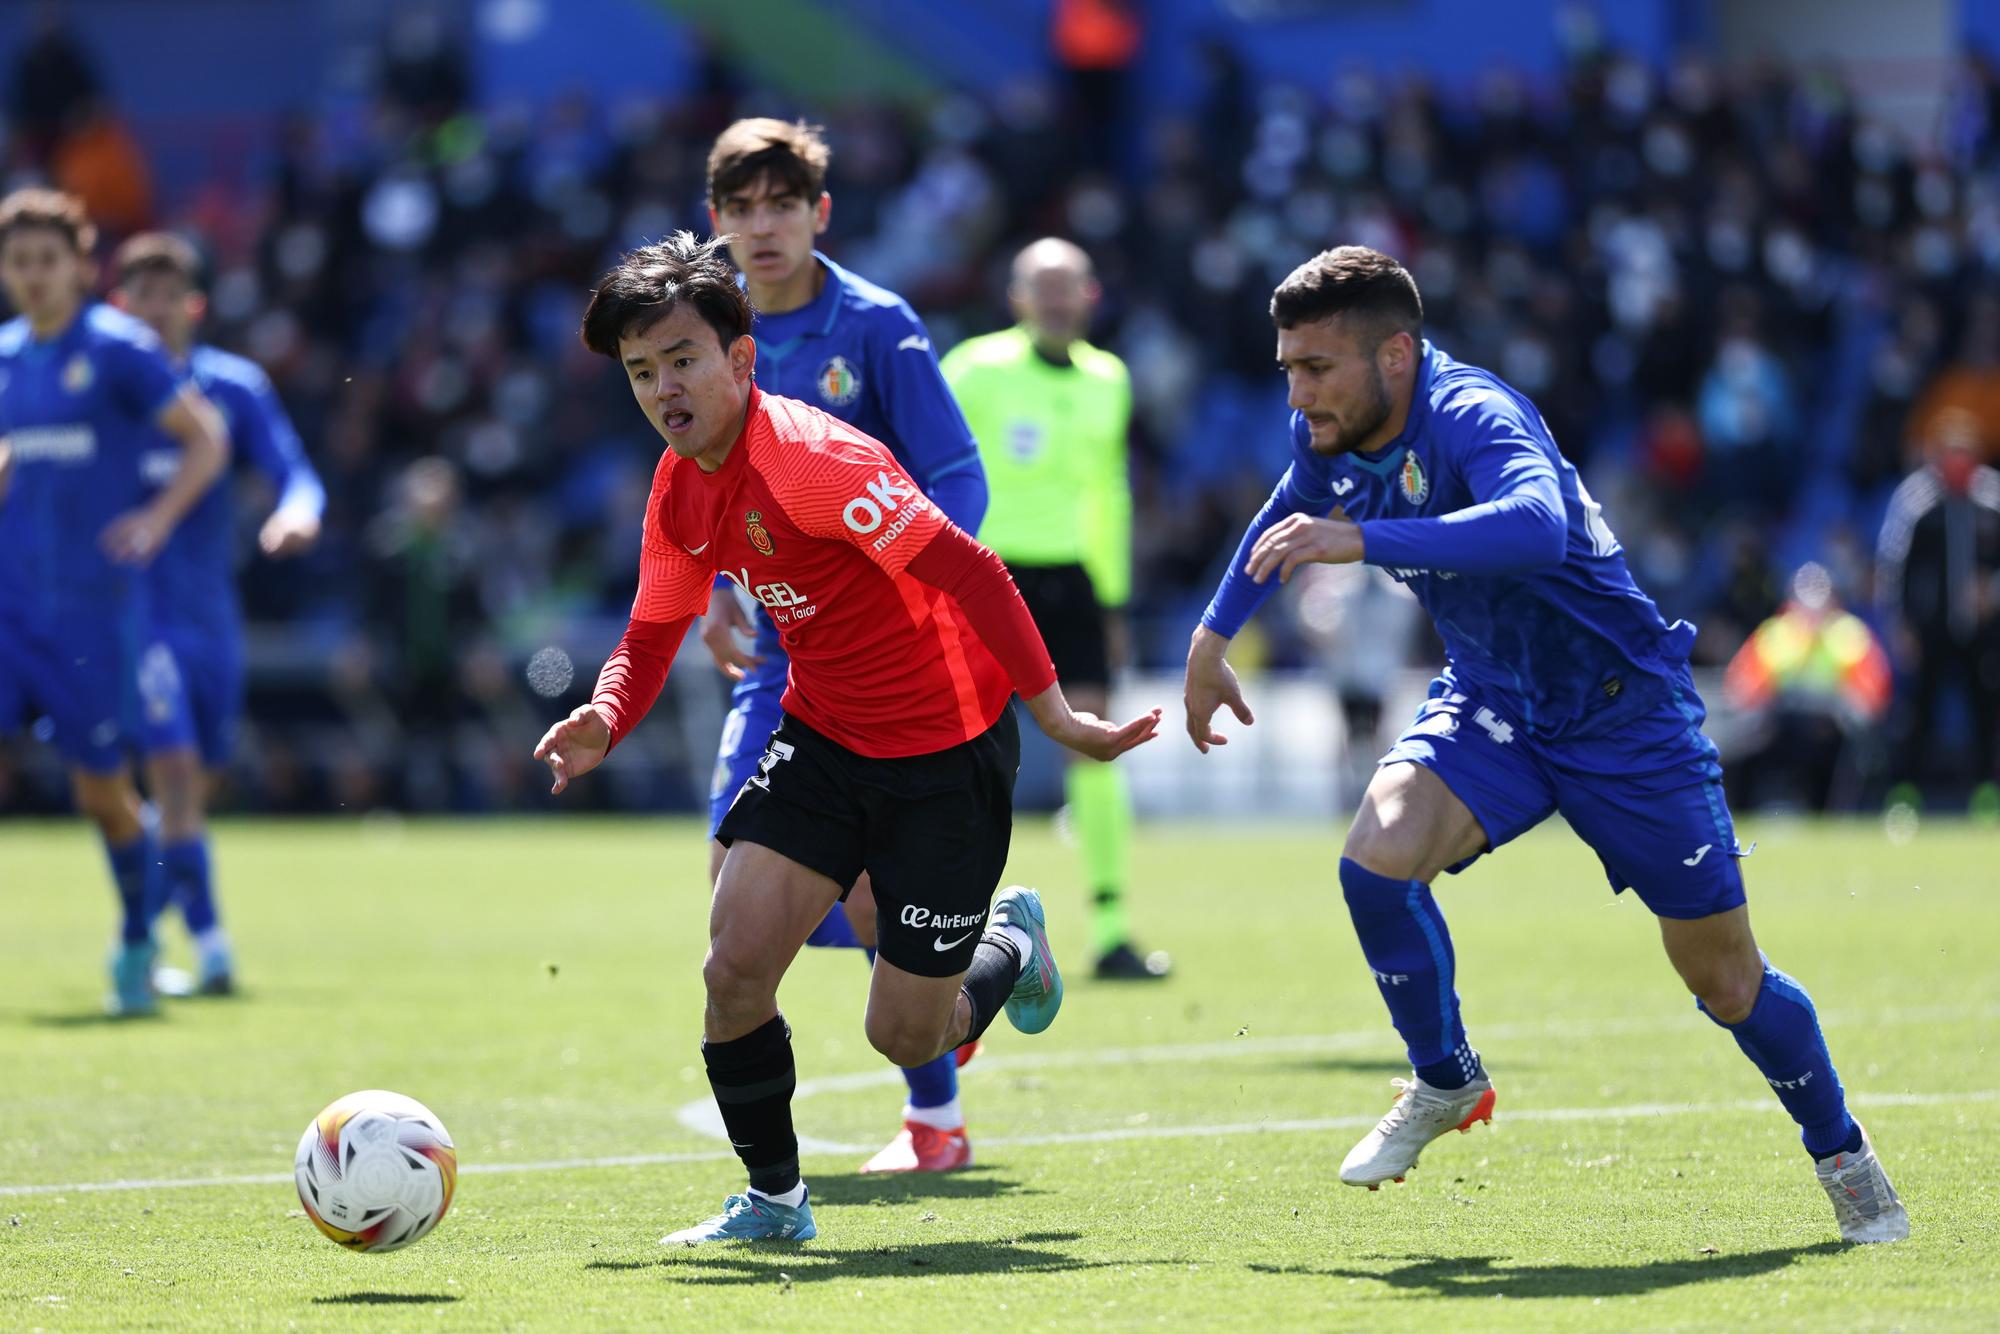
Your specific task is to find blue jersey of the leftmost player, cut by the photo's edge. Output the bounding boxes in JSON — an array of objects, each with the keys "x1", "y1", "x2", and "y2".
[{"x1": 0, "y1": 304, "x2": 180, "y2": 624}]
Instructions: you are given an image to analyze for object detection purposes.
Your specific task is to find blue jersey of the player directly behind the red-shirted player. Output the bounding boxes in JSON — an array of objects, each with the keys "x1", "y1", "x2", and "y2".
[{"x1": 752, "y1": 252, "x2": 986, "y2": 532}]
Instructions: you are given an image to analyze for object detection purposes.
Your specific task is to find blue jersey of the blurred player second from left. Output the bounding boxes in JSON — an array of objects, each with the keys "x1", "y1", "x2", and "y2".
[{"x1": 140, "y1": 346, "x2": 326, "y2": 626}]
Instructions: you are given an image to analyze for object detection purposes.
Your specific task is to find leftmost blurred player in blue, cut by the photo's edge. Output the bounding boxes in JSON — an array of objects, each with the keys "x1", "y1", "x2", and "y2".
[{"x1": 0, "y1": 190, "x2": 228, "y2": 1014}]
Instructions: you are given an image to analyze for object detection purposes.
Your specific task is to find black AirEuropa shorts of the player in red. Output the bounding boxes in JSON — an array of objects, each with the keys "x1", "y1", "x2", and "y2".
[{"x1": 716, "y1": 706, "x2": 1020, "y2": 978}]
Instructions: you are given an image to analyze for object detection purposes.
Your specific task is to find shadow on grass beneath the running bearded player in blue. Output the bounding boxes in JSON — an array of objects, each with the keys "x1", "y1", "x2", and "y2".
[{"x1": 1248, "y1": 1242, "x2": 1844, "y2": 1298}]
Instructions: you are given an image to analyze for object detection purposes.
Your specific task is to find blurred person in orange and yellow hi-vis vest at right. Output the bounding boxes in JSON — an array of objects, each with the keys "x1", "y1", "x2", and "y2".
[{"x1": 1722, "y1": 562, "x2": 1890, "y2": 810}]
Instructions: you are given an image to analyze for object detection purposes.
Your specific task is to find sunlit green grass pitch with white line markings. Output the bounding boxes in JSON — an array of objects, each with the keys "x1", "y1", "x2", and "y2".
[{"x1": 0, "y1": 818, "x2": 2000, "y2": 1332}]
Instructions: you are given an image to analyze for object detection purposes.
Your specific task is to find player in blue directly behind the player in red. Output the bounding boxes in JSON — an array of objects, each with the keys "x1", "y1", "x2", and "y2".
[{"x1": 702, "y1": 118, "x2": 986, "y2": 1172}]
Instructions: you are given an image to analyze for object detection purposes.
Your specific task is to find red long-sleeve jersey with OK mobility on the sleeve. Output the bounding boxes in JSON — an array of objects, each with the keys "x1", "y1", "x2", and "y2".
[{"x1": 594, "y1": 388, "x2": 1056, "y2": 758}]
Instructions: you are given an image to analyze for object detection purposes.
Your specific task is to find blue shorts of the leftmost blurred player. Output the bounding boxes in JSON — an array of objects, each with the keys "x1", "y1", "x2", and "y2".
[{"x1": 0, "y1": 610, "x2": 194, "y2": 774}]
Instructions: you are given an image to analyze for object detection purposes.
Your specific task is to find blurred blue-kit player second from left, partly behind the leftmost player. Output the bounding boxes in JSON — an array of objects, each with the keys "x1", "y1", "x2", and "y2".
[{"x1": 112, "y1": 232, "x2": 326, "y2": 996}]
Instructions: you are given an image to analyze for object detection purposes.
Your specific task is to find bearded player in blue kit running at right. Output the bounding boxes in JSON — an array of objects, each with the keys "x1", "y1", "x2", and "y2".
[{"x1": 1186, "y1": 246, "x2": 1910, "y2": 1242}]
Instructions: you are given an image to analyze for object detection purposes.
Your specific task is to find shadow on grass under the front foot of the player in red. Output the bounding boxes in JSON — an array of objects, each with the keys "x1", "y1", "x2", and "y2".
[{"x1": 584, "y1": 1232, "x2": 1128, "y2": 1288}]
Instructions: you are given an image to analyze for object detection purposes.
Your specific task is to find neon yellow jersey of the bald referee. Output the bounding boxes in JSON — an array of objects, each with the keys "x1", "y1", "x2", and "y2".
[{"x1": 942, "y1": 328, "x2": 1132, "y2": 606}]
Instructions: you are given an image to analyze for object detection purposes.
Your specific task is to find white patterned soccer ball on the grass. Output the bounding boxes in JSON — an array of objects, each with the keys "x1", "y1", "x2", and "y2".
[{"x1": 292, "y1": 1088, "x2": 458, "y2": 1252}]
